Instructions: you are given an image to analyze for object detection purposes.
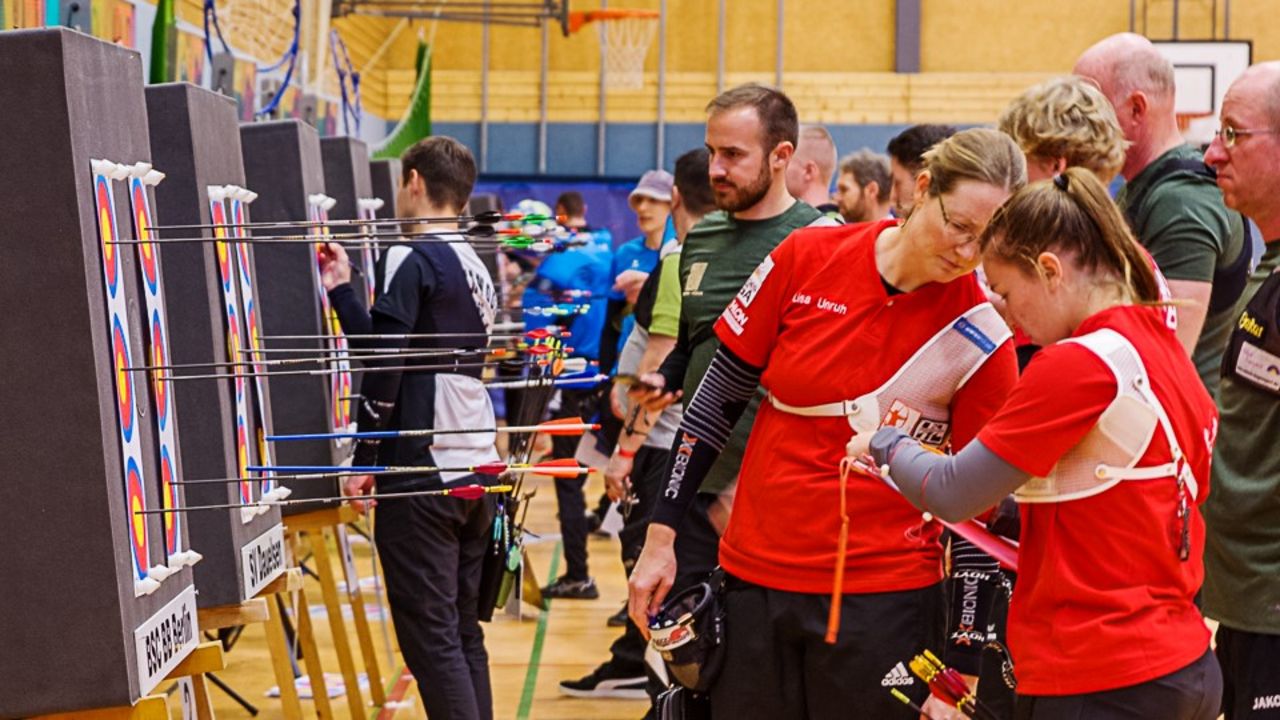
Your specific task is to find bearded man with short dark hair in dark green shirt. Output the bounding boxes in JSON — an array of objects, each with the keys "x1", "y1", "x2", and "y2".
[{"x1": 630, "y1": 85, "x2": 836, "y2": 632}]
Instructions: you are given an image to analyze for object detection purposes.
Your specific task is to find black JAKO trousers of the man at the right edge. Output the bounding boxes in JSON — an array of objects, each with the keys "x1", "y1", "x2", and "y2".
[{"x1": 1217, "y1": 625, "x2": 1280, "y2": 720}]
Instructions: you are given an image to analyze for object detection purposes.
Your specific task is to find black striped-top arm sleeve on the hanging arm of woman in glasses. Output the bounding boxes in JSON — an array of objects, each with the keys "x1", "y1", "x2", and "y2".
[{"x1": 650, "y1": 346, "x2": 763, "y2": 529}]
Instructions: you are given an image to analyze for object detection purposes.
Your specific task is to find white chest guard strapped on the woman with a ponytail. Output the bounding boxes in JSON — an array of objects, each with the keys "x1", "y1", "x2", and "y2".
[{"x1": 1014, "y1": 329, "x2": 1199, "y2": 502}]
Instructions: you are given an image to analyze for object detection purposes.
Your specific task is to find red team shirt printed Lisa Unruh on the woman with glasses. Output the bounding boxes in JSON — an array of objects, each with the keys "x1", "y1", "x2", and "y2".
[{"x1": 716, "y1": 220, "x2": 1018, "y2": 593}]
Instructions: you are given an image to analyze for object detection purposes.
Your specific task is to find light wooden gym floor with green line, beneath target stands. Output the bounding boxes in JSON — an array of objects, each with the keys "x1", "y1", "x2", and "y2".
[{"x1": 200, "y1": 474, "x2": 646, "y2": 720}]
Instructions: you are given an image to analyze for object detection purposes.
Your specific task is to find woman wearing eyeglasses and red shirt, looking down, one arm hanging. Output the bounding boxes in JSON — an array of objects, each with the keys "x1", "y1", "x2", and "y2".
[{"x1": 630, "y1": 128, "x2": 1025, "y2": 720}]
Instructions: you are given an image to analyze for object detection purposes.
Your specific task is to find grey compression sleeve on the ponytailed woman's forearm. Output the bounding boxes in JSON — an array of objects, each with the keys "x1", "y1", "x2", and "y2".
[{"x1": 872, "y1": 428, "x2": 1030, "y2": 523}]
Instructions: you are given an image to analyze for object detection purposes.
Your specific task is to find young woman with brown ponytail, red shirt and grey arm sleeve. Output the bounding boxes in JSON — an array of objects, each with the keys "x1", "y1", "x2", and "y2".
[{"x1": 849, "y1": 168, "x2": 1222, "y2": 720}]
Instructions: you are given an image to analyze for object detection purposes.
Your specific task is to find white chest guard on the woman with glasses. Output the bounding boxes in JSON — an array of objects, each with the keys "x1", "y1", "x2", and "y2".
[{"x1": 769, "y1": 302, "x2": 1012, "y2": 446}]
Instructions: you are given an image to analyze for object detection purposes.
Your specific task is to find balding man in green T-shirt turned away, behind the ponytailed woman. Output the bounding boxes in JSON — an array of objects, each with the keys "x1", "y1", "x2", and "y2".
[{"x1": 1075, "y1": 33, "x2": 1252, "y2": 395}]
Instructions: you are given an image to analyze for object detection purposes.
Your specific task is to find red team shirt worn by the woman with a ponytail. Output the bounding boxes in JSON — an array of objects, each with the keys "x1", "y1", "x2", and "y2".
[{"x1": 972, "y1": 306, "x2": 1217, "y2": 696}]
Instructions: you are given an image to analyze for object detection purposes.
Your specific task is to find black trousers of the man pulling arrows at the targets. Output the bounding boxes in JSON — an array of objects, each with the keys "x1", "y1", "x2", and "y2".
[{"x1": 374, "y1": 480, "x2": 493, "y2": 720}]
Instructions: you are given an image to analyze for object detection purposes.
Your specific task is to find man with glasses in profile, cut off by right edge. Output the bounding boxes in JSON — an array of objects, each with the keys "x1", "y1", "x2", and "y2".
[{"x1": 1203, "y1": 63, "x2": 1280, "y2": 720}]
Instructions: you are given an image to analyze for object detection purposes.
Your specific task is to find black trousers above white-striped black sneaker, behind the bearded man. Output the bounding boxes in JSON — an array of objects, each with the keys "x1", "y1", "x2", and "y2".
[{"x1": 609, "y1": 447, "x2": 671, "y2": 678}]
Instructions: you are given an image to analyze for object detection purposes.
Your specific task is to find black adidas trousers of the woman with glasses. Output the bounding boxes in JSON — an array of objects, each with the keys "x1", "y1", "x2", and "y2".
[{"x1": 712, "y1": 578, "x2": 943, "y2": 720}]
